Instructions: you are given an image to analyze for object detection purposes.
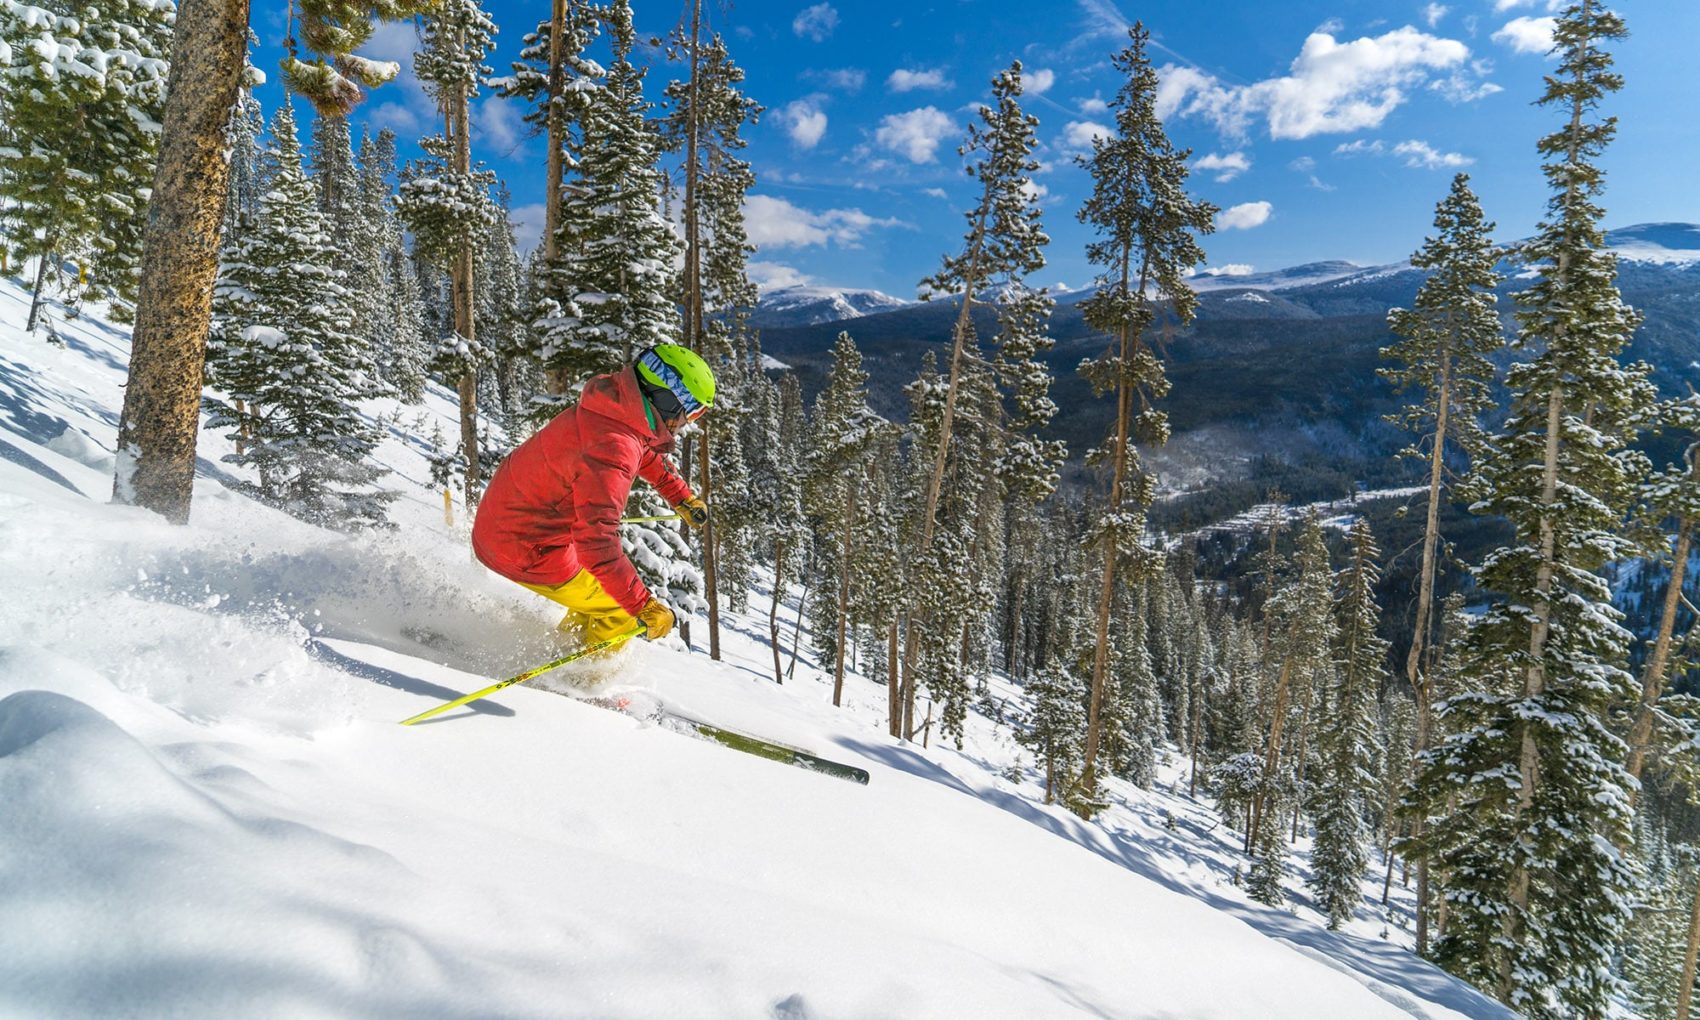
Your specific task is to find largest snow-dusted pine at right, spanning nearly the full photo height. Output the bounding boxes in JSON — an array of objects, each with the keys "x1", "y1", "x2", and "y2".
[{"x1": 1420, "y1": 0, "x2": 1652, "y2": 1018}]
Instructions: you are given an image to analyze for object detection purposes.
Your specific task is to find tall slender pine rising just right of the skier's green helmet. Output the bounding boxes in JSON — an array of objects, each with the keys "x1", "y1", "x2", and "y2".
[{"x1": 661, "y1": 23, "x2": 762, "y2": 660}]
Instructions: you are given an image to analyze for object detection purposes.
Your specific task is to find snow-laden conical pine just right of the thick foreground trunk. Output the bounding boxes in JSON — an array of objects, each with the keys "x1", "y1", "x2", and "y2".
[{"x1": 207, "y1": 102, "x2": 393, "y2": 527}]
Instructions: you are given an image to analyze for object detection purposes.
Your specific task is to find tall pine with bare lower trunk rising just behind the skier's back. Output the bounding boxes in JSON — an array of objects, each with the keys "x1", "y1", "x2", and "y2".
[{"x1": 396, "y1": 0, "x2": 498, "y2": 507}]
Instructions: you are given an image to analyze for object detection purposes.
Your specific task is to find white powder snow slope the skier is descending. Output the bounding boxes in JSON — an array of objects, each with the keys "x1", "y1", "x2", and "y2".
[{"x1": 0, "y1": 273, "x2": 1508, "y2": 1020}]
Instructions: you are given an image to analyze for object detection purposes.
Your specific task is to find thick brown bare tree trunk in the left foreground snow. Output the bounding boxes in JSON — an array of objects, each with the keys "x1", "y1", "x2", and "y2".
[{"x1": 112, "y1": 0, "x2": 248, "y2": 524}]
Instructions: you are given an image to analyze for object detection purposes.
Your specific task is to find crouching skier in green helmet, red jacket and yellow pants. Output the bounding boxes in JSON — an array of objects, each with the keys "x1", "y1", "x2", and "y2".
[{"x1": 473, "y1": 343, "x2": 714, "y2": 644}]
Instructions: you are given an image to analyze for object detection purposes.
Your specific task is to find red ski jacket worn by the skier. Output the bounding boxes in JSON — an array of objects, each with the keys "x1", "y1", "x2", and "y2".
[{"x1": 473, "y1": 366, "x2": 690, "y2": 615}]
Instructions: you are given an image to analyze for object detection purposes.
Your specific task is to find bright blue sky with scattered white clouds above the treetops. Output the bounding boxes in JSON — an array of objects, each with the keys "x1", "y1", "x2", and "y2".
[{"x1": 255, "y1": 0, "x2": 1700, "y2": 296}]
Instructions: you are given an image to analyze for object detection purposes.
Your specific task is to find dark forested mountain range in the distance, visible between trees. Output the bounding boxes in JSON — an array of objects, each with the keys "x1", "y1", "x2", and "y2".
[{"x1": 762, "y1": 223, "x2": 1700, "y2": 523}]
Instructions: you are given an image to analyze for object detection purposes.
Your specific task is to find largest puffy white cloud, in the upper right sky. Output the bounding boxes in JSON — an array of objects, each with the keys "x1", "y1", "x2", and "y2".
[{"x1": 1158, "y1": 26, "x2": 1471, "y2": 139}]
